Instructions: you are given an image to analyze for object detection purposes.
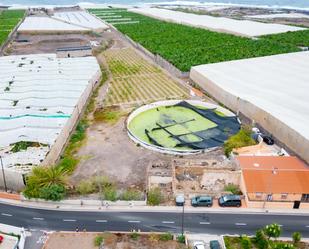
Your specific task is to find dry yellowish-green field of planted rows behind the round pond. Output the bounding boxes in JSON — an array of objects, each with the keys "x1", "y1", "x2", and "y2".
[{"x1": 104, "y1": 48, "x2": 188, "y2": 106}]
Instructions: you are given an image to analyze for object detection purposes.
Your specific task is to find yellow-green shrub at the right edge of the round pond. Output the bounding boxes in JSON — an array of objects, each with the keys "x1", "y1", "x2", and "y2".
[{"x1": 223, "y1": 128, "x2": 256, "y2": 157}]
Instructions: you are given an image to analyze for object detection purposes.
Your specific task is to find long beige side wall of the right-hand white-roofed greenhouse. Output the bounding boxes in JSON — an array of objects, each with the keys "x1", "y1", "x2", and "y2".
[{"x1": 190, "y1": 68, "x2": 309, "y2": 163}]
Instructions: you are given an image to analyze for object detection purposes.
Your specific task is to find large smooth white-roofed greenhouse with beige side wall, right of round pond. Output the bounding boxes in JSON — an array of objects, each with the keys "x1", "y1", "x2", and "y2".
[{"x1": 190, "y1": 52, "x2": 309, "y2": 162}]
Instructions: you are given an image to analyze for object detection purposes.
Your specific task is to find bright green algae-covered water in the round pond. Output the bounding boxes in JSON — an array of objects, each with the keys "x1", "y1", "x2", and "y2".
[{"x1": 128, "y1": 106, "x2": 217, "y2": 150}]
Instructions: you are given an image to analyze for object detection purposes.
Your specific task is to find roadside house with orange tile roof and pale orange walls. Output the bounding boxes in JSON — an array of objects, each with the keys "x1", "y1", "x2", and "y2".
[{"x1": 236, "y1": 156, "x2": 309, "y2": 209}]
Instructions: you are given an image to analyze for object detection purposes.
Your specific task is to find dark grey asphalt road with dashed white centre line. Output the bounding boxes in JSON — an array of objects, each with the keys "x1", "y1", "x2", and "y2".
[{"x1": 0, "y1": 204, "x2": 309, "y2": 235}]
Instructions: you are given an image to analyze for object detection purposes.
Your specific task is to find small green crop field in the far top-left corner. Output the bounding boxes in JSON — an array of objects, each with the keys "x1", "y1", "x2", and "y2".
[{"x1": 0, "y1": 10, "x2": 25, "y2": 46}]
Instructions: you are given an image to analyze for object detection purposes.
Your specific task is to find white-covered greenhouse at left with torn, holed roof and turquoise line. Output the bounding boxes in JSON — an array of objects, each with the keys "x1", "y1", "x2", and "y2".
[{"x1": 0, "y1": 54, "x2": 101, "y2": 190}]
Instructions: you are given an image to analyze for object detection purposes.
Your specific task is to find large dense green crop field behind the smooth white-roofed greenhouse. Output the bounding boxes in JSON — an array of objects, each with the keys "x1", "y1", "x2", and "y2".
[{"x1": 90, "y1": 10, "x2": 300, "y2": 71}]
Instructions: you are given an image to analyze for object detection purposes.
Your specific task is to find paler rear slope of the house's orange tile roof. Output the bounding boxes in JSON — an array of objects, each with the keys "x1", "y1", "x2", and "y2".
[{"x1": 236, "y1": 156, "x2": 309, "y2": 170}]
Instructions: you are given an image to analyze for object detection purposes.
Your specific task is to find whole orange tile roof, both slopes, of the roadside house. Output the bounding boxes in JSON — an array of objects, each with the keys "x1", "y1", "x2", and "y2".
[{"x1": 237, "y1": 156, "x2": 309, "y2": 194}]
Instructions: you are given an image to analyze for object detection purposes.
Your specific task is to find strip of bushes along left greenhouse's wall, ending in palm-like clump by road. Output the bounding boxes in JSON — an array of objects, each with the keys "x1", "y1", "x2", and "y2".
[{"x1": 23, "y1": 68, "x2": 108, "y2": 201}]
